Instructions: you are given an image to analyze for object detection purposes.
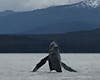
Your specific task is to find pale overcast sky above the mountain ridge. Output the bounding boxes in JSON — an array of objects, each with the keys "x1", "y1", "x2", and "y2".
[{"x1": 0, "y1": 0, "x2": 81, "y2": 11}]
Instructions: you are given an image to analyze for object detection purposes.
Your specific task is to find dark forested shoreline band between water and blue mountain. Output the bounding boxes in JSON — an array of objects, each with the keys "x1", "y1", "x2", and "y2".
[{"x1": 0, "y1": 29, "x2": 100, "y2": 53}]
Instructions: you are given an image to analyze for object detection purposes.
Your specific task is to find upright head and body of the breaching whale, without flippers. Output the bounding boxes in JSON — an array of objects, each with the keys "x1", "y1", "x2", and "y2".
[{"x1": 48, "y1": 41, "x2": 62, "y2": 72}]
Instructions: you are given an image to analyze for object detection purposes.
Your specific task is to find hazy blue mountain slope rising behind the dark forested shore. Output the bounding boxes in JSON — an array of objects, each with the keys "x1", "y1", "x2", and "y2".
[{"x1": 0, "y1": 0, "x2": 100, "y2": 34}]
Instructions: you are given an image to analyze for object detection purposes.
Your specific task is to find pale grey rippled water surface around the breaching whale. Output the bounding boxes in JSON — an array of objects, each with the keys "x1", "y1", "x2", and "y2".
[{"x1": 0, "y1": 54, "x2": 100, "y2": 80}]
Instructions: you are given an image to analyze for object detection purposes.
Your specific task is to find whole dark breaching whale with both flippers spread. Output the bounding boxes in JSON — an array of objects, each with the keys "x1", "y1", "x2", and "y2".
[{"x1": 32, "y1": 41, "x2": 77, "y2": 72}]
